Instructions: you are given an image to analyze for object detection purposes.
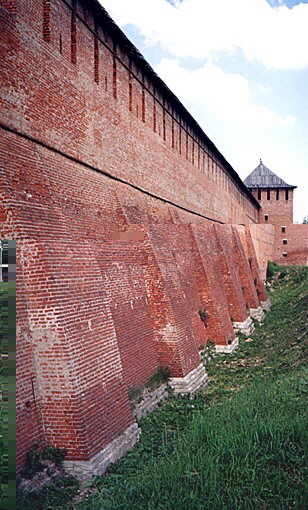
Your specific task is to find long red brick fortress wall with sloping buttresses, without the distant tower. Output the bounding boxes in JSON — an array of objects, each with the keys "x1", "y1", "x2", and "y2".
[{"x1": 0, "y1": 0, "x2": 272, "y2": 474}]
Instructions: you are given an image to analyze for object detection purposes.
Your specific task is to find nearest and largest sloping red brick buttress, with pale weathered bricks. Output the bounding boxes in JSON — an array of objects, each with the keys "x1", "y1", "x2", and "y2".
[{"x1": 17, "y1": 240, "x2": 133, "y2": 459}]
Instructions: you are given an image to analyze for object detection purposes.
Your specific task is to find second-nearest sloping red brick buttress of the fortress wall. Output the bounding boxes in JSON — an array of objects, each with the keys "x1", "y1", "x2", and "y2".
[{"x1": 149, "y1": 225, "x2": 205, "y2": 377}]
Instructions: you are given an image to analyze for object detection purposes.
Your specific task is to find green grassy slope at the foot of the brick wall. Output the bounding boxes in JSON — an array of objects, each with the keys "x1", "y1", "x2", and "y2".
[{"x1": 18, "y1": 267, "x2": 308, "y2": 510}]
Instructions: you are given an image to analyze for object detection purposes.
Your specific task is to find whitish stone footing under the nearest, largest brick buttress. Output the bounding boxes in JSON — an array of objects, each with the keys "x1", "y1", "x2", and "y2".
[{"x1": 63, "y1": 423, "x2": 141, "y2": 481}]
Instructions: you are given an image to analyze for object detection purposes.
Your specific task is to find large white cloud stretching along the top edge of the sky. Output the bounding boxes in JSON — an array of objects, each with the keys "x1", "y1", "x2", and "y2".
[{"x1": 102, "y1": 0, "x2": 308, "y2": 69}]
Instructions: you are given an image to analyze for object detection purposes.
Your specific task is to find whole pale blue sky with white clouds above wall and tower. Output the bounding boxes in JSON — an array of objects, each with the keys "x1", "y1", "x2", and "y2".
[{"x1": 100, "y1": 0, "x2": 308, "y2": 222}]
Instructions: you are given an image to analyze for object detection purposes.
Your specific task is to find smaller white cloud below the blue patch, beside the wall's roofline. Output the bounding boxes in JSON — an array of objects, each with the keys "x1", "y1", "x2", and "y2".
[{"x1": 155, "y1": 58, "x2": 296, "y2": 131}]
